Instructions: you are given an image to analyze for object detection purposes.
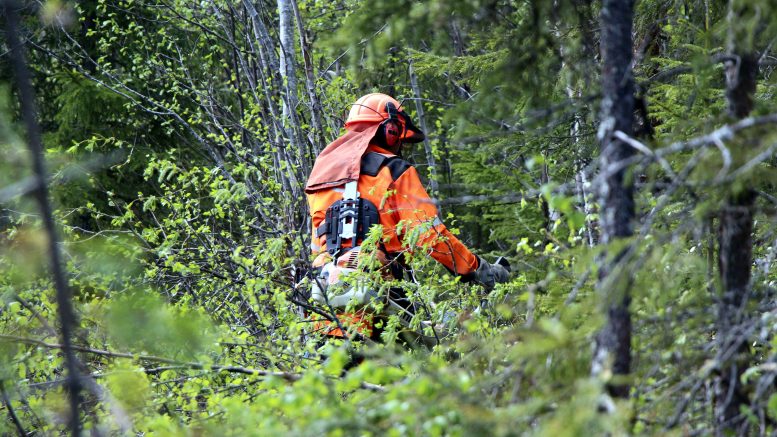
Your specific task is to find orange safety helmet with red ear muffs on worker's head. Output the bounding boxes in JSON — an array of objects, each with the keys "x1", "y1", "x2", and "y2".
[{"x1": 345, "y1": 93, "x2": 426, "y2": 143}]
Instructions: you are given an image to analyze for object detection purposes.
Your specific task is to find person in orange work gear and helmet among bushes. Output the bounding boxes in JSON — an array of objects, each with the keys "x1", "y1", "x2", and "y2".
[{"x1": 305, "y1": 93, "x2": 508, "y2": 337}]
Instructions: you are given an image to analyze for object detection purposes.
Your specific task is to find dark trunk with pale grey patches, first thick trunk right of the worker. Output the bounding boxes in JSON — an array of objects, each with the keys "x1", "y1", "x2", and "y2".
[{"x1": 591, "y1": 0, "x2": 634, "y2": 397}]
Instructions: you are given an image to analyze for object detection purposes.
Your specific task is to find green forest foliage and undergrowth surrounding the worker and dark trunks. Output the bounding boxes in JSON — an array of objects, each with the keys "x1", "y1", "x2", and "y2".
[{"x1": 0, "y1": 0, "x2": 777, "y2": 436}]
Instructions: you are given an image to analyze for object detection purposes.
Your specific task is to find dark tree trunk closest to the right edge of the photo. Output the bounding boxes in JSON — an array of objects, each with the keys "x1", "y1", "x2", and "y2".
[{"x1": 715, "y1": 52, "x2": 758, "y2": 432}]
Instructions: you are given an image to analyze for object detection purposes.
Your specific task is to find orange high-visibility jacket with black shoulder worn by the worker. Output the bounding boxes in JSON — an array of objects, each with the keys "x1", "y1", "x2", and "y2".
[{"x1": 307, "y1": 144, "x2": 478, "y2": 275}]
